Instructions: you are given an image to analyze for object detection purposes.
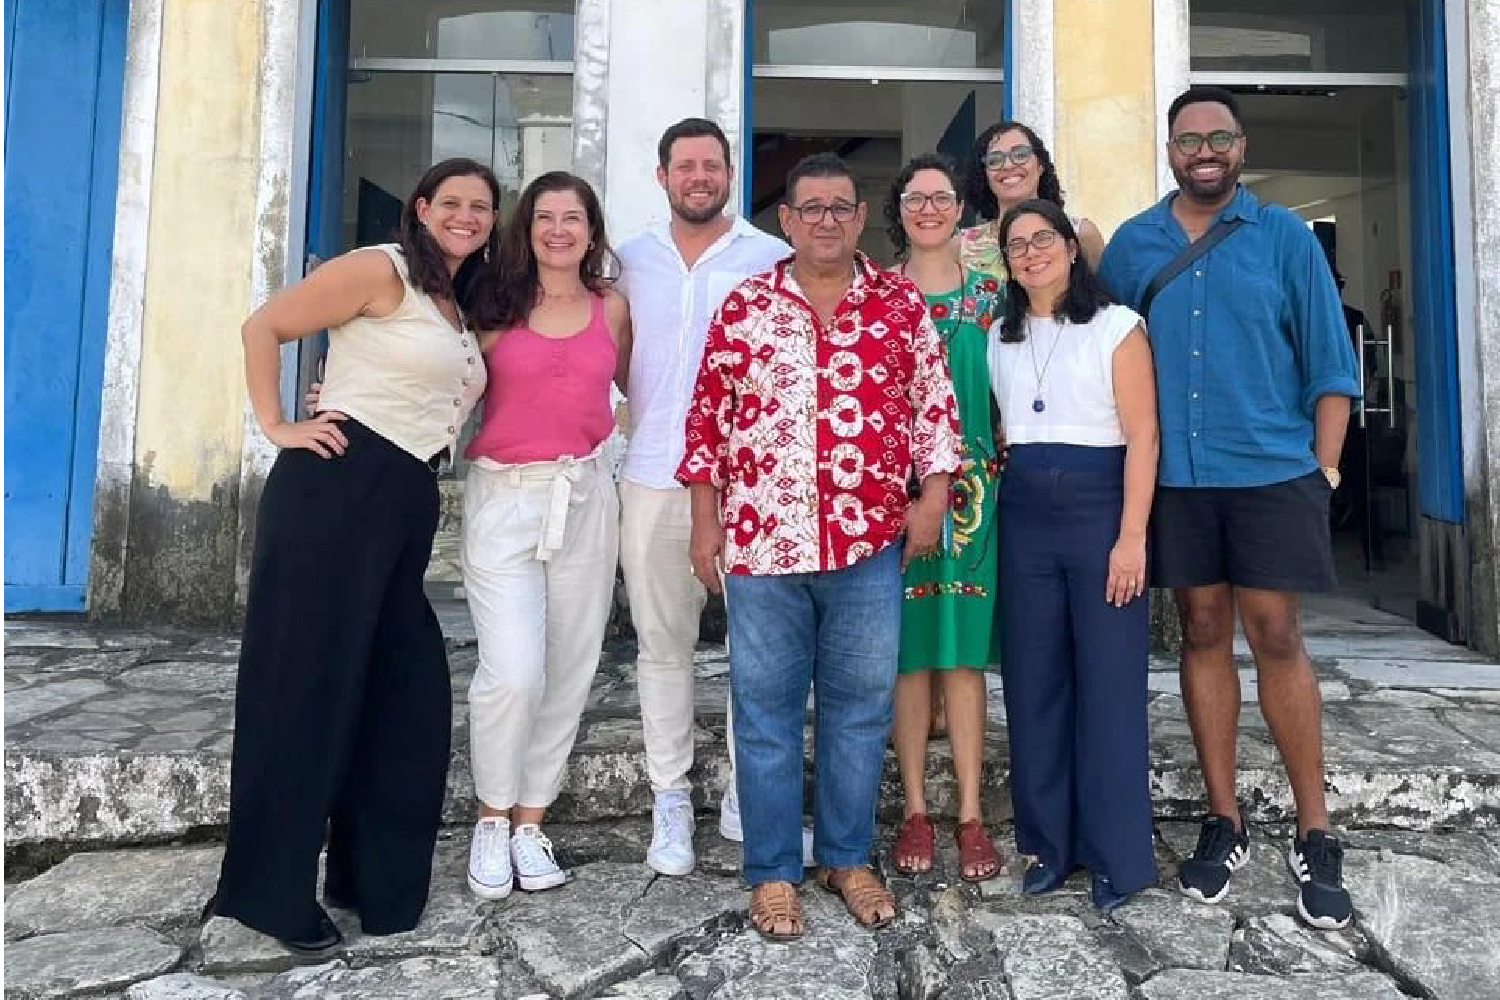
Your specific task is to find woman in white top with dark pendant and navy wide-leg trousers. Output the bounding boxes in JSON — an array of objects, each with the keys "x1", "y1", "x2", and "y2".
[{"x1": 990, "y1": 199, "x2": 1158, "y2": 912}]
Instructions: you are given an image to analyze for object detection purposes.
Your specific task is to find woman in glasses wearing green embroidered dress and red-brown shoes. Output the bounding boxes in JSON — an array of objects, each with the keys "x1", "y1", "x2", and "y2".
[{"x1": 885, "y1": 154, "x2": 1002, "y2": 882}]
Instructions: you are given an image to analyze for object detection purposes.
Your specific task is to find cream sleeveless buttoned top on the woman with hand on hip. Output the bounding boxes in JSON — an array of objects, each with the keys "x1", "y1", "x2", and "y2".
[{"x1": 318, "y1": 243, "x2": 486, "y2": 462}]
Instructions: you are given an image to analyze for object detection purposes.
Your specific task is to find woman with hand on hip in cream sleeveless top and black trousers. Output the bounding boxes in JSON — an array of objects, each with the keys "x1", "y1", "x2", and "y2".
[{"x1": 212, "y1": 159, "x2": 500, "y2": 955}]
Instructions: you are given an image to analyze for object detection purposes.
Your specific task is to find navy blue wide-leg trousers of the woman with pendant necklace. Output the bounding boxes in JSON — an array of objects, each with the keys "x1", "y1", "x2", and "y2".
[{"x1": 999, "y1": 444, "x2": 1157, "y2": 892}]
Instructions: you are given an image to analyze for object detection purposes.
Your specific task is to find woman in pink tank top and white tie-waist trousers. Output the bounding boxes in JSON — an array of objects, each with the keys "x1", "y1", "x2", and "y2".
[{"x1": 450, "y1": 171, "x2": 630, "y2": 900}]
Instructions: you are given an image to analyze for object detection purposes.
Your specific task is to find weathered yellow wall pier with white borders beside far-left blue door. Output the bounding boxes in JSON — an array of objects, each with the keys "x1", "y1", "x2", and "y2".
[{"x1": 90, "y1": 0, "x2": 300, "y2": 624}]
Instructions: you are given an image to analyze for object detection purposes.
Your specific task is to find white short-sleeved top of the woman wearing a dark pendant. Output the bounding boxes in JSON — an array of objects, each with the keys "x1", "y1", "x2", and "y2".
[{"x1": 990, "y1": 306, "x2": 1140, "y2": 448}]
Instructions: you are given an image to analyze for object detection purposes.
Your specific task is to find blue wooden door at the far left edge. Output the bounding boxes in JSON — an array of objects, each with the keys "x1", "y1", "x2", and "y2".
[{"x1": 5, "y1": 0, "x2": 129, "y2": 612}]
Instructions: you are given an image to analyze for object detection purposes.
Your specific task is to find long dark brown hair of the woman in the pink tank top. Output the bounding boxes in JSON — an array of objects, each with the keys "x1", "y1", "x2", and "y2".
[{"x1": 470, "y1": 169, "x2": 620, "y2": 330}]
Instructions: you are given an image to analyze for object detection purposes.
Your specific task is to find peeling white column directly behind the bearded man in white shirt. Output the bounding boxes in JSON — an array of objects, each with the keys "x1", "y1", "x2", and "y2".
[{"x1": 573, "y1": 0, "x2": 746, "y2": 243}]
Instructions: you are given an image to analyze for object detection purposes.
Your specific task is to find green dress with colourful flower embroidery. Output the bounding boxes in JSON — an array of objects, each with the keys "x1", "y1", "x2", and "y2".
[{"x1": 900, "y1": 270, "x2": 1002, "y2": 673}]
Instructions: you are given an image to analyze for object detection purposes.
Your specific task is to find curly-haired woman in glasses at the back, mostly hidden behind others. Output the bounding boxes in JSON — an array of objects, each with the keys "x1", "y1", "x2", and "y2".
[{"x1": 959, "y1": 121, "x2": 1104, "y2": 282}]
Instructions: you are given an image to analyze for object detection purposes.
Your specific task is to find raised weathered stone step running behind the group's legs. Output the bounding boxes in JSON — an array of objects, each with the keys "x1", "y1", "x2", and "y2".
[{"x1": 5, "y1": 601, "x2": 1500, "y2": 849}]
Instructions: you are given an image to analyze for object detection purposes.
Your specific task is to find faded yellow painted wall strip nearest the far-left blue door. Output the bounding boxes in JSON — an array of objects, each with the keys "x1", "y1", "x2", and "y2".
[{"x1": 135, "y1": 0, "x2": 263, "y2": 502}]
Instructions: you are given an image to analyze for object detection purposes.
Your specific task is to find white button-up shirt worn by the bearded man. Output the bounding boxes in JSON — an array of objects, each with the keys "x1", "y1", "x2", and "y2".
[{"x1": 618, "y1": 216, "x2": 792, "y2": 490}]
